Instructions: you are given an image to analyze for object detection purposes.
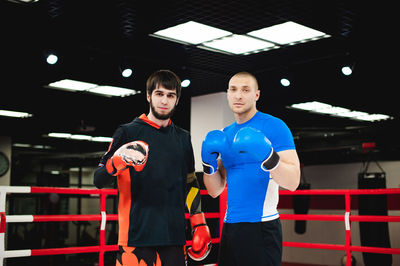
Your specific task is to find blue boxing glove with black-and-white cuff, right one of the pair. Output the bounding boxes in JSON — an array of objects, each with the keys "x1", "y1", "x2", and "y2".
[{"x1": 232, "y1": 127, "x2": 280, "y2": 172}]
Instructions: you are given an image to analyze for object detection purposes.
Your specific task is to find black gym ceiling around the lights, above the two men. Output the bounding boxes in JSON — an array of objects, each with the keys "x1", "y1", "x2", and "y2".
[{"x1": 0, "y1": 0, "x2": 400, "y2": 166}]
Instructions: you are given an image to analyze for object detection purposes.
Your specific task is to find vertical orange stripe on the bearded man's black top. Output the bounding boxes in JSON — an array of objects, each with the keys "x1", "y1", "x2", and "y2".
[{"x1": 118, "y1": 170, "x2": 132, "y2": 246}]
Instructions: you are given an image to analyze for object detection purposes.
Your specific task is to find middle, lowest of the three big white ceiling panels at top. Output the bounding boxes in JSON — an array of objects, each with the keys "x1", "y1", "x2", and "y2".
[{"x1": 199, "y1": 34, "x2": 275, "y2": 54}]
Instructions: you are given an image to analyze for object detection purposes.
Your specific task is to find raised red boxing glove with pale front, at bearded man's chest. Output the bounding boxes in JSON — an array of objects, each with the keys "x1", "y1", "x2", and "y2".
[{"x1": 106, "y1": 140, "x2": 149, "y2": 176}]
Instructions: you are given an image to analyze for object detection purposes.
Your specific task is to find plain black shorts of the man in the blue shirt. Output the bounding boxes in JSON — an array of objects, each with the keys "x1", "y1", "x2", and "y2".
[{"x1": 218, "y1": 218, "x2": 282, "y2": 266}]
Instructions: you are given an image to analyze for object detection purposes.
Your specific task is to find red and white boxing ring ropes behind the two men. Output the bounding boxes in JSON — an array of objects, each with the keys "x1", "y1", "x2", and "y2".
[{"x1": 0, "y1": 186, "x2": 400, "y2": 266}]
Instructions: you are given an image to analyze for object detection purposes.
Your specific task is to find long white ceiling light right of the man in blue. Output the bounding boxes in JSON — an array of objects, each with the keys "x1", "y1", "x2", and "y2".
[{"x1": 290, "y1": 101, "x2": 393, "y2": 122}]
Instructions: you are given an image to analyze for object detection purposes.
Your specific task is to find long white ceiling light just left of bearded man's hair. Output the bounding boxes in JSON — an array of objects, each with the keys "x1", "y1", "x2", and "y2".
[{"x1": 48, "y1": 79, "x2": 136, "y2": 97}]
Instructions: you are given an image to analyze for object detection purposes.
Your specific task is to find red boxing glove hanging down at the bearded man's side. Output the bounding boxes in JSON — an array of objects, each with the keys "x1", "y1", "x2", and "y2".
[{"x1": 188, "y1": 212, "x2": 211, "y2": 261}]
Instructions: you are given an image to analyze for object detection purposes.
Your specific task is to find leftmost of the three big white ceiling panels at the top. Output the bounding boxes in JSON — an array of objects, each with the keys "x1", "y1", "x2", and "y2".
[{"x1": 151, "y1": 21, "x2": 232, "y2": 44}]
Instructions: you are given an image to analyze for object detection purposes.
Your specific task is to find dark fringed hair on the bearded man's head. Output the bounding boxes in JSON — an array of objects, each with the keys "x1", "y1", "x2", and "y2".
[{"x1": 146, "y1": 69, "x2": 182, "y2": 98}]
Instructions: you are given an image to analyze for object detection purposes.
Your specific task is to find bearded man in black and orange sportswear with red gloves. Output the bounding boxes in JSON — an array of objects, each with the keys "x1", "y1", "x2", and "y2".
[{"x1": 94, "y1": 70, "x2": 211, "y2": 266}]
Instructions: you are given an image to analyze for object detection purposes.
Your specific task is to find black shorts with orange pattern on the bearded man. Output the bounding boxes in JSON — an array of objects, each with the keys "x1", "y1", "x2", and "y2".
[{"x1": 116, "y1": 246, "x2": 186, "y2": 266}]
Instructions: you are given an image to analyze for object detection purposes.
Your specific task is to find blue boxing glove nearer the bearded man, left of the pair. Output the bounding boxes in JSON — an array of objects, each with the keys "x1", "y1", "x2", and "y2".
[{"x1": 201, "y1": 130, "x2": 228, "y2": 175}]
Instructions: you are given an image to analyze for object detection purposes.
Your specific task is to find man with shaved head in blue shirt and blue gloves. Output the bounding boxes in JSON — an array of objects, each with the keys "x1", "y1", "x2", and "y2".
[{"x1": 201, "y1": 72, "x2": 300, "y2": 266}]
